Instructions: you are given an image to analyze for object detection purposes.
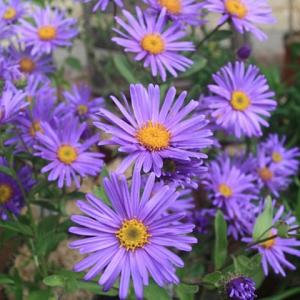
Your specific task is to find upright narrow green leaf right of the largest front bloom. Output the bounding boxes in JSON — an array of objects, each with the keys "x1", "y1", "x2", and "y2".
[{"x1": 214, "y1": 210, "x2": 228, "y2": 270}]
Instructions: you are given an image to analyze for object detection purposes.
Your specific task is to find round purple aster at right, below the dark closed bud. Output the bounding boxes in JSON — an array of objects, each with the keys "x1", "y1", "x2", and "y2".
[{"x1": 206, "y1": 62, "x2": 276, "y2": 138}]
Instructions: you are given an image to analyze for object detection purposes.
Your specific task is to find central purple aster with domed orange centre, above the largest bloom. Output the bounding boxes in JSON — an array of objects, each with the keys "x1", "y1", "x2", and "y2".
[{"x1": 95, "y1": 84, "x2": 212, "y2": 177}]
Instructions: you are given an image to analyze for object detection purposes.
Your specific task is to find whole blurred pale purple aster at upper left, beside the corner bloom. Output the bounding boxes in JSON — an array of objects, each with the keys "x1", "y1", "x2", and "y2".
[{"x1": 19, "y1": 6, "x2": 78, "y2": 55}]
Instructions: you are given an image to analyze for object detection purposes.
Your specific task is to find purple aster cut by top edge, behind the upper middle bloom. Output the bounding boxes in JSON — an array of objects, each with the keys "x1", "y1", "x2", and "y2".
[{"x1": 144, "y1": 0, "x2": 204, "y2": 26}]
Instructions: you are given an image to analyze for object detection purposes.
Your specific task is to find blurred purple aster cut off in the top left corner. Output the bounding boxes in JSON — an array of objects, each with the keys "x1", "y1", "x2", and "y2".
[{"x1": 0, "y1": 0, "x2": 25, "y2": 24}]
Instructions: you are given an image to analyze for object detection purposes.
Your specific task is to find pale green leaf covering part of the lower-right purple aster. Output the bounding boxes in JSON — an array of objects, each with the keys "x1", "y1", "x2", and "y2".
[{"x1": 252, "y1": 197, "x2": 273, "y2": 242}]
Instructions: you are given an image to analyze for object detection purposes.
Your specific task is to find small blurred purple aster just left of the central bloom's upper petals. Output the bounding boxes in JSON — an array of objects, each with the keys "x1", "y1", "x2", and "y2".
[{"x1": 57, "y1": 84, "x2": 104, "y2": 120}]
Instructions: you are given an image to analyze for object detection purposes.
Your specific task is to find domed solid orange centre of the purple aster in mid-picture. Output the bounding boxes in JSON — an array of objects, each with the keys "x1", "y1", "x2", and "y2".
[{"x1": 136, "y1": 121, "x2": 171, "y2": 151}]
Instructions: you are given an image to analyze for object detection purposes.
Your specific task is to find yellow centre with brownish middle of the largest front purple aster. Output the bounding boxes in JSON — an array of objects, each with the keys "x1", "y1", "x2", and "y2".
[{"x1": 116, "y1": 219, "x2": 150, "y2": 251}]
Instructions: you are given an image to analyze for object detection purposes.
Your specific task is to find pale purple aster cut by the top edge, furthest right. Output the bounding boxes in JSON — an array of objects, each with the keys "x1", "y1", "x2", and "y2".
[{"x1": 204, "y1": 0, "x2": 276, "y2": 40}]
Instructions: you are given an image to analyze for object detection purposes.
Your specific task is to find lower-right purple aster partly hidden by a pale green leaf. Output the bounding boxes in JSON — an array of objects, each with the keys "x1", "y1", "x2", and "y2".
[{"x1": 243, "y1": 207, "x2": 300, "y2": 276}]
